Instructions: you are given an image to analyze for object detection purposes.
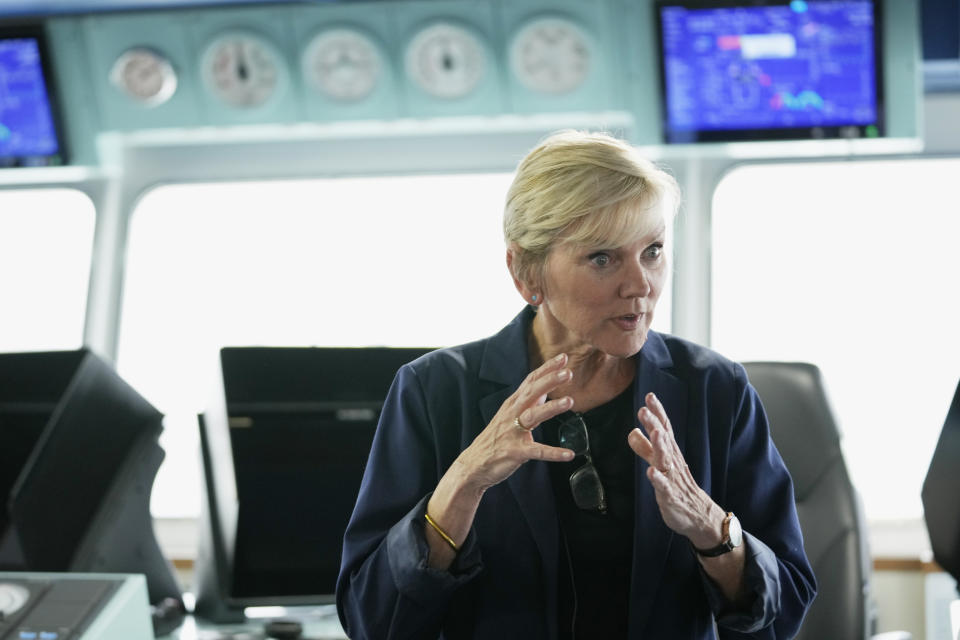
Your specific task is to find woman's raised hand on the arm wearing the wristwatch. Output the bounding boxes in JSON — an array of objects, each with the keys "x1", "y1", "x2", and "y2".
[{"x1": 627, "y1": 393, "x2": 726, "y2": 549}]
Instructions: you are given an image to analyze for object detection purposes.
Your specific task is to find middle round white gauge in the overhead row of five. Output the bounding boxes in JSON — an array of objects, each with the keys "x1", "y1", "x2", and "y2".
[{"x1": 302, "y1": 28, "x2": 383, "y2": 102}]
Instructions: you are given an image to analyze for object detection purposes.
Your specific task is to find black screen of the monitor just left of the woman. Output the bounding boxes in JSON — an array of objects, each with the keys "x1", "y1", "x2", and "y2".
[{"x1": 231, "y1": 408, "x2": 379, "y2": 603}]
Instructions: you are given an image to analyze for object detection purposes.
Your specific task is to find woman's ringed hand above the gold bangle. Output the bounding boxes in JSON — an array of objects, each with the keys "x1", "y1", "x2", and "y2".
[{"x1": 457, "y1": 353, "x2": 573, "y2": 495}]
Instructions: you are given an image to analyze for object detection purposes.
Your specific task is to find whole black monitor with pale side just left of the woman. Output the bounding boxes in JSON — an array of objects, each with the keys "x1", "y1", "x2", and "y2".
[{"x1": 195, "y1": 347, "x2": 429, "y2": 622}]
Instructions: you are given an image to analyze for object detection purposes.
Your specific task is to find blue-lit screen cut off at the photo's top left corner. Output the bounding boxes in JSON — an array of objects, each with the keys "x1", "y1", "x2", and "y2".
[{"x1": 0, "y1": 26, "x2": 65, "y2": 168}]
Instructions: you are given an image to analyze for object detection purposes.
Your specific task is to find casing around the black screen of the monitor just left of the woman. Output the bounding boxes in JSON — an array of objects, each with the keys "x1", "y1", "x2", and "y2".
[{"x1": 195, "y1": 347, "x2": 433, "y2": 623}]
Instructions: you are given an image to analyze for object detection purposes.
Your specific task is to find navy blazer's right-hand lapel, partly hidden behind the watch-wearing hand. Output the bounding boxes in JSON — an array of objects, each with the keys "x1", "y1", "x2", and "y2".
[{"x1": 630, "y1": 332, "x2": 687, "y2": 638}]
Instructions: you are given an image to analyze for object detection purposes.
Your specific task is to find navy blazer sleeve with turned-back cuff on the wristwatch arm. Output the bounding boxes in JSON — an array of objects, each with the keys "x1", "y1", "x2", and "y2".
[{"x1": 697, "y1": 364, "x2": 816, "y2": 640}]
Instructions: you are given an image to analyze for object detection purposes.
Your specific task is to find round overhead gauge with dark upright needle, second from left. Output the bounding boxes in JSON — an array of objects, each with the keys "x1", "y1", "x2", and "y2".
[{"x1": 201, "y1": 32, "x2": 282, "y2": 109}]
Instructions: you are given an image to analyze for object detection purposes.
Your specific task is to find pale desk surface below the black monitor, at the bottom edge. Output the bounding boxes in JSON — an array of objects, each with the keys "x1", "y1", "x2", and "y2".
[{"x1": 158, "y1": 605, "x2": 347, "y2": 640}]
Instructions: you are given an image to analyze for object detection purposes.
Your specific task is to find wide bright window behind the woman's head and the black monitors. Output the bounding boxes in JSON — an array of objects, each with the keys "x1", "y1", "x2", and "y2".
[{"x1": 118, "y1": 174, "x2": 669, "y2": 517}]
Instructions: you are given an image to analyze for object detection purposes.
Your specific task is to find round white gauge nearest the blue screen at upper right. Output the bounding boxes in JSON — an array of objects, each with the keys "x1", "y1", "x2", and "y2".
[{"x1": 510, "y1": 17, "x2": 591, "y2": 94}]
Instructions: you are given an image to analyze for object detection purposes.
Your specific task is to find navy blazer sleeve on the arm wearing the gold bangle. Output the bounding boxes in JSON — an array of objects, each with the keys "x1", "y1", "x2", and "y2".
[{"x1": 336, "y1": 365, "x2": 481, "y2": 640}]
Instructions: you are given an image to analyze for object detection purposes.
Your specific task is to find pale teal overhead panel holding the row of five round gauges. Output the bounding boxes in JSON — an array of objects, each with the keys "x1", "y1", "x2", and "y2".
[{"x1": 35, "y1": 0, "x2": 920, "y2": 165}]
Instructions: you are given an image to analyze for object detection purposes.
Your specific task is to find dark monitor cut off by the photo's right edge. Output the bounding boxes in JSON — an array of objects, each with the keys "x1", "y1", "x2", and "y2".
[{"x1": 920, "y1": 383, "x2": 960, "y2": 583}]
